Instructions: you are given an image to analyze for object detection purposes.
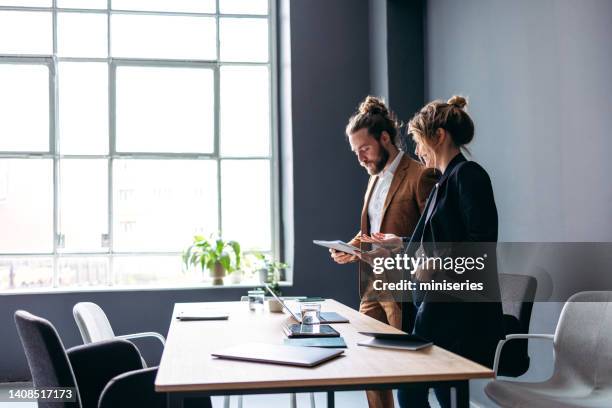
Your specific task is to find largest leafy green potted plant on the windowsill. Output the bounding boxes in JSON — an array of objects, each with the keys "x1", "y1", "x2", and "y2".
[{"x1": 183, "y1": 235, "x2": 241, "y2": 285}]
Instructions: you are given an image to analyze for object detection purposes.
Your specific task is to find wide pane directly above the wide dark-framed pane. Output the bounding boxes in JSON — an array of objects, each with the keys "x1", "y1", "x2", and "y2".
[{"x1": 111, "y1": 14, "x2": 217, "y2": 60}]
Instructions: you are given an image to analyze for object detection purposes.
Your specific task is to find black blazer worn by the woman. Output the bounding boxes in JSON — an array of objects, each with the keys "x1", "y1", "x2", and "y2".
[{"x1": 402, "y1": 153, "x2": 504, "y2": 366}]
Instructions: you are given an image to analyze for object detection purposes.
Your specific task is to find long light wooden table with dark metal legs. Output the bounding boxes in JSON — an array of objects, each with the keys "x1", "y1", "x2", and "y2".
[{"x1": 155, "y1": 300, "x2": 493, "y2": 407}]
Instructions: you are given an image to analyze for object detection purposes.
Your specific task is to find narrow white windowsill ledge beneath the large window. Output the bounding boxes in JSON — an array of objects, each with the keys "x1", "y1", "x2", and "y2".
[{"x1": 0, "y1": 281, "x2": 293, "y2": 296}]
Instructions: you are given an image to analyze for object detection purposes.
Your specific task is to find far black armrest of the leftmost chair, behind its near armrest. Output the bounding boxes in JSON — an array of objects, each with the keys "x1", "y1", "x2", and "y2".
[{"x1": 66, "y1": 339, "x2": 142, "y2": 408}]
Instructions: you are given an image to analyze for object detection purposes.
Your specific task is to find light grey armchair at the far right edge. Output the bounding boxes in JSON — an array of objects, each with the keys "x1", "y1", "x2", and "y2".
[{"x1": 485, "y1": 292, "x2": 612, "y2": 408}]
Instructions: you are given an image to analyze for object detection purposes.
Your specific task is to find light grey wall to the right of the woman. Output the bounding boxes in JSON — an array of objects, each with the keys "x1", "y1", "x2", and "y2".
[{"x1": 425, "y1": 0, "x2": 612, "y2": 406}]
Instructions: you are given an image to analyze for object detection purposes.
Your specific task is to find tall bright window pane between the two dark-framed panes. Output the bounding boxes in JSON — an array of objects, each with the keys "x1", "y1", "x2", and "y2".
[{"x1": 58, "y1": 62, "x2": 108, "y2": 154}]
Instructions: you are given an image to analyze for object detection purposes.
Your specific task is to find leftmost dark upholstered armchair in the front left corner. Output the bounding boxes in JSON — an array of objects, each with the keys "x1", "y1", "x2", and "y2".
[{"x1": 15, "y1": 310, "x2": 191, "y2": 408}]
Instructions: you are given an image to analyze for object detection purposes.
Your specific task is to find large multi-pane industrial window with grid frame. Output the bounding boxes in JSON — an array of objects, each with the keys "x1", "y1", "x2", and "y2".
[{"x1": 0, "y1": 0, "x2": 278, "y2": 290}]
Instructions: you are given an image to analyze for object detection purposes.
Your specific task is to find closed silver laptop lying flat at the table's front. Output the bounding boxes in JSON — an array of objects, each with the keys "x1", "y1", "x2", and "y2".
[{"x1": 211, "y1": 343, "x2": 344, "y2": 367}]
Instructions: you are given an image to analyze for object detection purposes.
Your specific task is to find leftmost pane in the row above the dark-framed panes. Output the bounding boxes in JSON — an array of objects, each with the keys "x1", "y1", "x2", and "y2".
[{"x1": 0, "y1": 11, "x2": 53, "y2": 55}]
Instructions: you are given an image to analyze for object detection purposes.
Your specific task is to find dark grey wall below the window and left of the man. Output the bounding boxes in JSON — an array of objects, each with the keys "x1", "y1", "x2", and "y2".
[{"x1": 0, "y1": 0, "x2": 370, "y2": 381}]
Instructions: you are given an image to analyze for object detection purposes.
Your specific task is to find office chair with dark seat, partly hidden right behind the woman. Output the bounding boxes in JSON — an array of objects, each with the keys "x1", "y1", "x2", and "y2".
[{"x1": 497, "y1": 273, "x2": 538, "y2": 377}]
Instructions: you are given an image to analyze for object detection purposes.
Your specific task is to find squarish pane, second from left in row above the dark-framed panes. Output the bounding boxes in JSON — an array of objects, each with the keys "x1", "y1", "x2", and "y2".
[{"x1": 57, "y1": 13, "x2": 108, "y2": 57}]
